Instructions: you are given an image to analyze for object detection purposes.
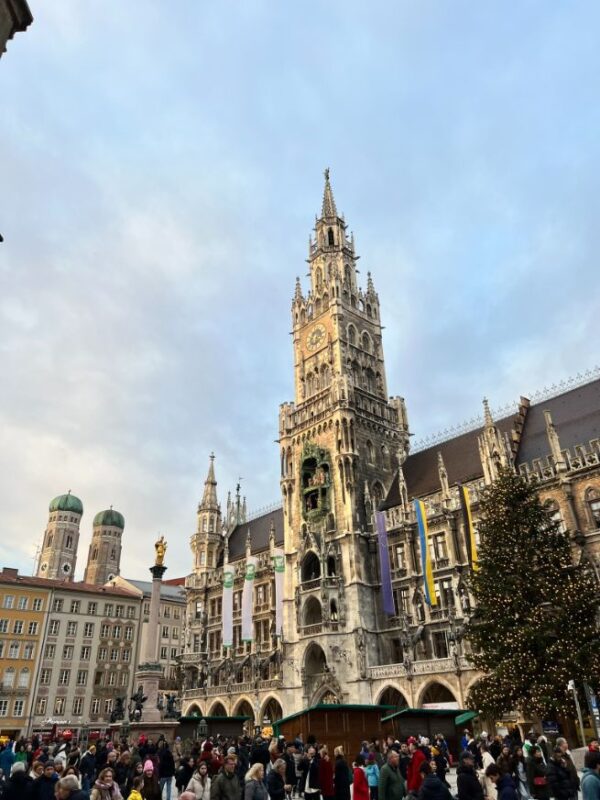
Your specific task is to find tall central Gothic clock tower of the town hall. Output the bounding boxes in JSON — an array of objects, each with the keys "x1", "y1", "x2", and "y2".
[{"x1": 279, "y1": 171, "x2": 409, "y2": 707}]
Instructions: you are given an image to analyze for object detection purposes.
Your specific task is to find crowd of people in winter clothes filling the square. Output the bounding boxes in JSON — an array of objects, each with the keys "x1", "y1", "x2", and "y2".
[{"x1": 0, "y1": 731, "x2": 600, "y2": 800}]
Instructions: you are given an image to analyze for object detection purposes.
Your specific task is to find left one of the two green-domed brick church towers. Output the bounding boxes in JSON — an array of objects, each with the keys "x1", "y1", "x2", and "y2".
[{"x1": 36, "y1": 491, "x2": 83, "y2": 581}]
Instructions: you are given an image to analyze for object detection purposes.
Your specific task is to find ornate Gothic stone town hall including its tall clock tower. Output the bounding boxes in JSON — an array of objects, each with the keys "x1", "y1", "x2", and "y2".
[{"x1": 181, "y1": 174, "x2": 600, "y2": 722}]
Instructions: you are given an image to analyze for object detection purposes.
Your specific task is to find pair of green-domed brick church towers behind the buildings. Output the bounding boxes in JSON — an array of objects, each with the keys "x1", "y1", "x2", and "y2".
[{"x1": 36, "y1": 492, "x2": 125, "y2": 584}]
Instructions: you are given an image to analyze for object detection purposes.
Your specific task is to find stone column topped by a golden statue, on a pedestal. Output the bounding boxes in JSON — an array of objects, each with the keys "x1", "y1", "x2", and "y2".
[{"x1": 134, "y1": 536, "x2": 167, "y2": 722}]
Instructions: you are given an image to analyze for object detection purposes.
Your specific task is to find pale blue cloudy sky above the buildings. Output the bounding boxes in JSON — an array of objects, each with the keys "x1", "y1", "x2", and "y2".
[{"x1": 0, "y1": 0, "x2": 600, "y2": 577}]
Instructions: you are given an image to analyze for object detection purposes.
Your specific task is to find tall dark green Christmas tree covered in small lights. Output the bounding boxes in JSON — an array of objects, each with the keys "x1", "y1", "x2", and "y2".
[{"x1": 465, "y1": 470, "x2": 600, "y2": 719}]
